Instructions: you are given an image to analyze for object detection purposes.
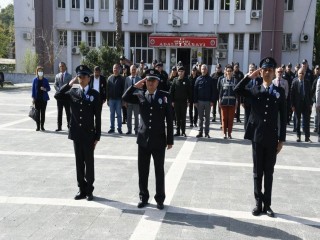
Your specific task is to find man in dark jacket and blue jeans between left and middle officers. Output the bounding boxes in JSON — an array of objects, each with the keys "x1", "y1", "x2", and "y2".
[{"x1": 106, "y1": 64, "x2": 125, "y2": 134}]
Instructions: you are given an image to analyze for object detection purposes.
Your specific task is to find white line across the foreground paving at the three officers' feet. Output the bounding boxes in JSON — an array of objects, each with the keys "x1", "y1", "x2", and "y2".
[{"x1": 0, "y1": 196, "x2": 320, "y2": 226}]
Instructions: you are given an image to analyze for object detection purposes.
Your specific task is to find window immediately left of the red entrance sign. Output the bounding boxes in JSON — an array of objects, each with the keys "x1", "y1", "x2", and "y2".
[{"x1": 130, "y1": 33, "x2": 153, "y2": 63}]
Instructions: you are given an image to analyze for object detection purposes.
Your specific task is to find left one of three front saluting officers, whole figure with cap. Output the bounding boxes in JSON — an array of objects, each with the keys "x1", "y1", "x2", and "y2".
[{"x1": 55, "y1": 65, "x2": 101, "y2": 201}]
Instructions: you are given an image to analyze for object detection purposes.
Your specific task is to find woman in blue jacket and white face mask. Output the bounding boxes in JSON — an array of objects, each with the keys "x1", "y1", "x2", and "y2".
[{"x1": 32, "y1": 66, "x2": 51, "y2": 131}]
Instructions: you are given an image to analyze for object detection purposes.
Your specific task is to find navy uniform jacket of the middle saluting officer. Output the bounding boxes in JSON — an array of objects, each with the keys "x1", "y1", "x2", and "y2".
[{"x1": 122, "y1": 86, "x2": 173, "y2": 149}]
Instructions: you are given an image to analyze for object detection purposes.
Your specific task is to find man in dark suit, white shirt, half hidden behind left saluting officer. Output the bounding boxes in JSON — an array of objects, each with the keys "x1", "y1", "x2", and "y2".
[{"x1": 89, "y1": 66, "x2": 107, "y2": 110}]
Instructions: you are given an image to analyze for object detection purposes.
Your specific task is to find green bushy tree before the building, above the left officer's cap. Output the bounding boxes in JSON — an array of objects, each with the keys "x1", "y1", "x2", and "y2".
[{"x1": 79, "y1": 42, "x2": 122, "y2": 76}]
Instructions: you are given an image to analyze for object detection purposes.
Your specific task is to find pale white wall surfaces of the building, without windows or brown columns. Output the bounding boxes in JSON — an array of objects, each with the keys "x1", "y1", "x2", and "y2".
[{"x1": 14, "y1": 0, "x2": 316, "y2": 72}]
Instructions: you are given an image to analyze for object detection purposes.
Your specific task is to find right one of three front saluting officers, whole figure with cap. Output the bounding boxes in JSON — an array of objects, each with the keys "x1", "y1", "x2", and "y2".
[{"x1": 234, "y1": 57, "x2": 287, "y2": 217}]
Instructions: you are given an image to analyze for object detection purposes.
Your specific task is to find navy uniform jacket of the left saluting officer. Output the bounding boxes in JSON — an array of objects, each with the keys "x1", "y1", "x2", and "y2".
[{"x1": 54, "y1": 84, "x2": 101, "y2": 143}]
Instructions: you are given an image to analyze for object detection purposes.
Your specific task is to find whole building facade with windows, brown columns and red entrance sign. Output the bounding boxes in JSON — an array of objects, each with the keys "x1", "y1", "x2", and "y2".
[{"x1": 14, "y1": 0, "x2": 316, "y2": 73}]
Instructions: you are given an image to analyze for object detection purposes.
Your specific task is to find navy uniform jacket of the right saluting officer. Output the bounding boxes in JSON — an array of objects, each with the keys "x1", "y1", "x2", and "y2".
[{"x1": 234, "y1": 77, "x2": 287, "y2": 144}]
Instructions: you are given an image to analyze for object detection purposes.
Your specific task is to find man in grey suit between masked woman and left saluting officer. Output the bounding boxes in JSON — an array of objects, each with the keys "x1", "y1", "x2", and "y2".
[{"x1": 54, "y1": 62, "x2": 72, "y2": 132}]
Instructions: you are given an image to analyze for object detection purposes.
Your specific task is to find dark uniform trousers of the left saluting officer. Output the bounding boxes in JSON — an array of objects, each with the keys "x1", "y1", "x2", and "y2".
[{"x1": 73, "y1": 141, "x2": 94, "y2": 195}]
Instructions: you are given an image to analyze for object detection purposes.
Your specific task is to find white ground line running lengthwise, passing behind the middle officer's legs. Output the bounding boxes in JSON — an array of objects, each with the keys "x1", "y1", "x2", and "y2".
[{"x1": 130, "y1": 130, "x2": 197, "y2": 240}]
